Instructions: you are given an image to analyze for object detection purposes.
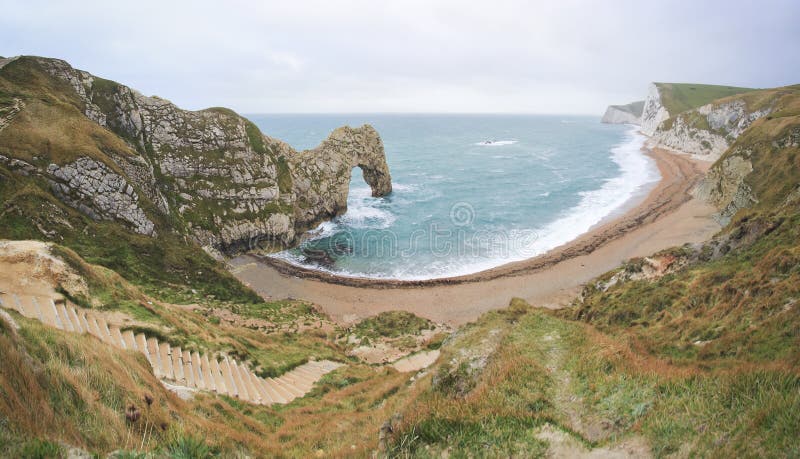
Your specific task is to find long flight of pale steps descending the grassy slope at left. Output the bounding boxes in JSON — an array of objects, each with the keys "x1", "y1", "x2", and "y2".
[{"x1": 0, "y1": 293, "x2": 342, "y2": 405}]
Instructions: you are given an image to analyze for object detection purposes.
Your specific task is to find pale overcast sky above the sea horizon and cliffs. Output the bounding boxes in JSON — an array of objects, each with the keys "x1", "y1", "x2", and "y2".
[{"x1": 0, "y1": 0, "x2": 800, "y2": 115}]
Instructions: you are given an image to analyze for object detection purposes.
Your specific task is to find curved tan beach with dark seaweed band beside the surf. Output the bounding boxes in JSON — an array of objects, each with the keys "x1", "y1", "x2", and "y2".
[{"x1": 230, "y1": 149, "x2": 720, "y2": 326}]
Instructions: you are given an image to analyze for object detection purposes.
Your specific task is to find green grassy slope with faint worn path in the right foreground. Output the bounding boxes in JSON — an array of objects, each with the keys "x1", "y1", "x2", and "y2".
[{"x1": 392, "y1": 304, "x2": 800, "y2": 457}]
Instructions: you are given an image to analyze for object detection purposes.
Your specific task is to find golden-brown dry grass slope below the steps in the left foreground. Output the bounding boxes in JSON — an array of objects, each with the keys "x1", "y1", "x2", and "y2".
[{"x1": 0, "y1": 315, "x2": 432, "y2": 457}]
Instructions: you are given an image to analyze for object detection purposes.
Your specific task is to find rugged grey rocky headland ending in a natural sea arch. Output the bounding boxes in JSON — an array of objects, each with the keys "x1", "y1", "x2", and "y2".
[{"x1": 0, "y1": 57, "x2": 391, "y2": 252}]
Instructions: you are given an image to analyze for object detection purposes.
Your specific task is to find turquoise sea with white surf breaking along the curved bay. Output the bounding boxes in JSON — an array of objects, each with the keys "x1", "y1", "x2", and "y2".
[{"x1": 249, "y1": 114, "x2": 659, "y2": 279}]
